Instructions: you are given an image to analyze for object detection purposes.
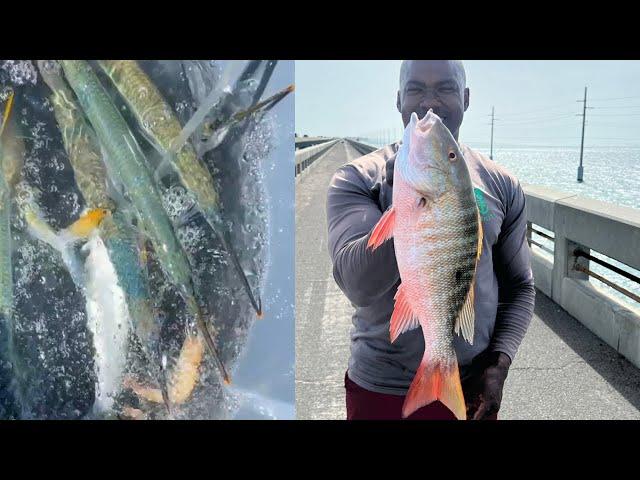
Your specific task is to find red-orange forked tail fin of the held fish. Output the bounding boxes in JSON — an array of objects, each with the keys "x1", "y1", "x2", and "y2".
[{"x1": 402, "y1": 358, "x2": 467, "y2": 420}]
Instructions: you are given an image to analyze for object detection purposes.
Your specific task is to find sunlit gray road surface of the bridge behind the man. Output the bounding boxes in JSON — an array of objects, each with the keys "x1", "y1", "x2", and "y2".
[{"x1": 296, "y1": 142, "x2": 640, "y2": 420}]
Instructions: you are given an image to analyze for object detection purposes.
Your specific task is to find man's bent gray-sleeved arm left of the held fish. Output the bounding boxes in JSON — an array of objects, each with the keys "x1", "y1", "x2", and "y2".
[{"x1": 327, "y1": 165, "x2": 400, "y2": 307}]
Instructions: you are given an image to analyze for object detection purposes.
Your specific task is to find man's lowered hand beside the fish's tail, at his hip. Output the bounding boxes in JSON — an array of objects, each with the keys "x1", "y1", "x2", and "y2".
[{"x1": 465, "y1": 352, "x2": 511, "y2": 420}]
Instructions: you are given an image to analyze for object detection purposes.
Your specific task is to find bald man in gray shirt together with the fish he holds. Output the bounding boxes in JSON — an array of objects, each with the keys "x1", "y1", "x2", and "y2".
[{"x1": 327, "y1": 60, "x2": 535, "y2": 420}]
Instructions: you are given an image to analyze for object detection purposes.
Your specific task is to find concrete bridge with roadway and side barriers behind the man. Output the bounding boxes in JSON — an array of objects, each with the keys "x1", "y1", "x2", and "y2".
[{"x1": 295, "y1": 138, "x2": 640, "y2": 420}]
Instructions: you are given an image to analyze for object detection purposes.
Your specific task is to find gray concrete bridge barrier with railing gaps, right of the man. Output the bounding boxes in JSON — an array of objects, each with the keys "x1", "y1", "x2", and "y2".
[{"x1": 523, "y1": 185, "x2": 640, "y2": 367}]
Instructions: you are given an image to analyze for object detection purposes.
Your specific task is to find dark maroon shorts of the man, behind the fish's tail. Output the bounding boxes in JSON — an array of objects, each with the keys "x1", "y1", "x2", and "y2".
[{"x1": 344, "y1": 373, "x2": 498, "y2": 420}]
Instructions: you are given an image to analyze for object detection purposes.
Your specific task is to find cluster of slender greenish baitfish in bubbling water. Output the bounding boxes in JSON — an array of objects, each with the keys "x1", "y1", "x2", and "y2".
[{"x1": 0, "y1": 60, "x2": 293, "y2": 419}]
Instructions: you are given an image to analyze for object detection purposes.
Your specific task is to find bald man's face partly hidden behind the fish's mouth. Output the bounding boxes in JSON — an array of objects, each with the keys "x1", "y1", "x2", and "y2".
[{"x1": 397, "y1": 60, "x2": 469, "y2": 140}]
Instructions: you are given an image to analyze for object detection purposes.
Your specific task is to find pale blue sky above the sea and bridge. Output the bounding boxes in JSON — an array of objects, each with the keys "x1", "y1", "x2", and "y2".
[{"x1": 295, "y1": 60, "x2": 640, "y2": 147}]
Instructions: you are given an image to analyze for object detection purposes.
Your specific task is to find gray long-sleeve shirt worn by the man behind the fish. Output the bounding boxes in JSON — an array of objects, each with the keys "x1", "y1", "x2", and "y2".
[{"x1": 327, "y1": 144, "x2": 535, "y2": 395}]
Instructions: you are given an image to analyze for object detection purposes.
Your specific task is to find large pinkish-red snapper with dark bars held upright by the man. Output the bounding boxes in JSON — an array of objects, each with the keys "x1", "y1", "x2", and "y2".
[{"x1": 368, "y1": 110, "x2": 482, "y2": 419}]
